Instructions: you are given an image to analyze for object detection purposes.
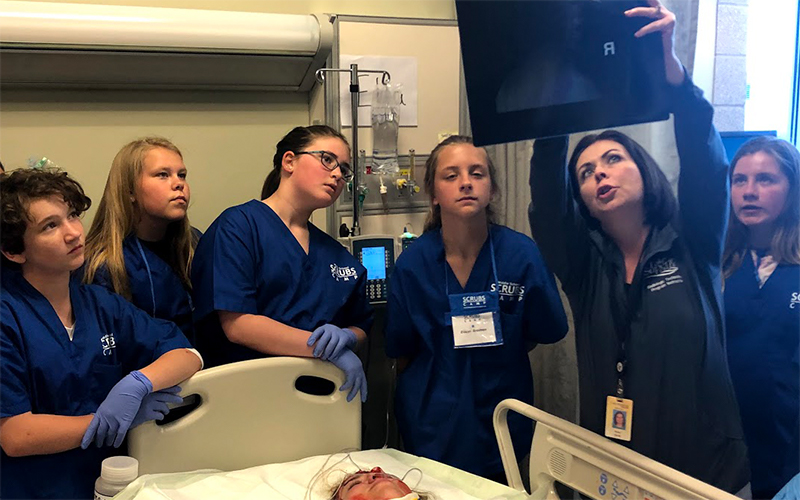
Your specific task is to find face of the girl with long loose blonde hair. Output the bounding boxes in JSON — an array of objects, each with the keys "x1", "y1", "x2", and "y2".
[{"x1": 134, "y1": 148, "x2": 191, "y2": 229}]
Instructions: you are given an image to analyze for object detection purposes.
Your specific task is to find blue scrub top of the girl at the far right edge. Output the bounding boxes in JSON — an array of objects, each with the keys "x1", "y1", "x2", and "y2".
[{"x1": 725, "y1": 252, "x2": 800, "y2": 498}]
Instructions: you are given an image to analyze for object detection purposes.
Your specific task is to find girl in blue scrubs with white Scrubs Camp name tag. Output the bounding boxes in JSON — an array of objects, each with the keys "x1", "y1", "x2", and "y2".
[{"x1": 386, "y1": 136, "x2": 567, "y2": 481}]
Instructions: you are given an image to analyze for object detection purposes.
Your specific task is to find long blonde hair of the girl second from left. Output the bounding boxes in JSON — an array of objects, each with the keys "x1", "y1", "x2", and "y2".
[{"x1": 83, "y1": 137, "x2": 195, "y2": 300}]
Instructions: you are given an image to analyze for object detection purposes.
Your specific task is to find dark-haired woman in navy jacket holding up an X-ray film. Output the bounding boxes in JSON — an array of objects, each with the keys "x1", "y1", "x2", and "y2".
[{"x1": 530, "y1": 0, "x2": 749, "y2": 492}]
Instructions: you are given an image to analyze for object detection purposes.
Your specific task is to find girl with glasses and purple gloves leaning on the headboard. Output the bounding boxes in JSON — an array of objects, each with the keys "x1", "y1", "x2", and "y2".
[{"x1": 192, "y1": 125, "x2": 372, "y2": 400}]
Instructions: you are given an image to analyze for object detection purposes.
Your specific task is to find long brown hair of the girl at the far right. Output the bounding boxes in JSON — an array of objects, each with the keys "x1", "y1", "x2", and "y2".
[{"x1": 722, "y1": 136, "x2": 800, "y2": 278}]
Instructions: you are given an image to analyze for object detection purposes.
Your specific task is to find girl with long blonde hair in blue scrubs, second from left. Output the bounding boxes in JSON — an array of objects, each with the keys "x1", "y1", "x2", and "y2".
[{"x1": 83, "y1": 137, "x2": 199, "y2": 338}]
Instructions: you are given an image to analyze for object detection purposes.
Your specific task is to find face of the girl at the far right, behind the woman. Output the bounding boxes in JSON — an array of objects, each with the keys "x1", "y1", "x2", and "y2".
[{"x1": 731, "y1": 151, "x2": 789, "y2": 229}]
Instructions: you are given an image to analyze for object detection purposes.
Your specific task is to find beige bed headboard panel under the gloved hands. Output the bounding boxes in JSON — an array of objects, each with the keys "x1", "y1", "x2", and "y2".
[{"x1": 128, "y1": 357, "x2": 361, "y2": 474}]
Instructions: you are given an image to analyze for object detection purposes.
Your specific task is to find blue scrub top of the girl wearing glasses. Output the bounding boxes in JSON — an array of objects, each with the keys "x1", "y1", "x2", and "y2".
[{"x1": 192, "y1": 200, "x2": 372, "y2": 366}]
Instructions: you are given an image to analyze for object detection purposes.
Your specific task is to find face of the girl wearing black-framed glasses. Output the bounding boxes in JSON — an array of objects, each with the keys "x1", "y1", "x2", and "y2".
[{"x1": 283, "y1": 137, "x2": 350, "y2": 209}]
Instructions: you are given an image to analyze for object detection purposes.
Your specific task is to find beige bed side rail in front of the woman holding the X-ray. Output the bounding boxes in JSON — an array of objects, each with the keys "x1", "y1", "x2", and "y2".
[{"x1": 494, "y1": 399, "x2": 737, "y2": 500}]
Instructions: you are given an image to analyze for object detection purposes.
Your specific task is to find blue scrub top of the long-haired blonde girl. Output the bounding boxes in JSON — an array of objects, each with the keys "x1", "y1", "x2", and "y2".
[{"x1": 94, "y1": 235, "x2": 194, "y2": 339}]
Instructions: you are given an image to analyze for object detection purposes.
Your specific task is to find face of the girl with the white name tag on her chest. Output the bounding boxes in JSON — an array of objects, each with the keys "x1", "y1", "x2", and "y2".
[{"x1": 433, "y1": 144, "x2": 492, "y2": 219}]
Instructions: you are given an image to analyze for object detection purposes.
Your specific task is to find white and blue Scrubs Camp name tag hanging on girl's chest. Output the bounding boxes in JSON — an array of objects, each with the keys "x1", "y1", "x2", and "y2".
[{"x1": 448, "y1": 292, "x2": 503, "y2": 349}]
